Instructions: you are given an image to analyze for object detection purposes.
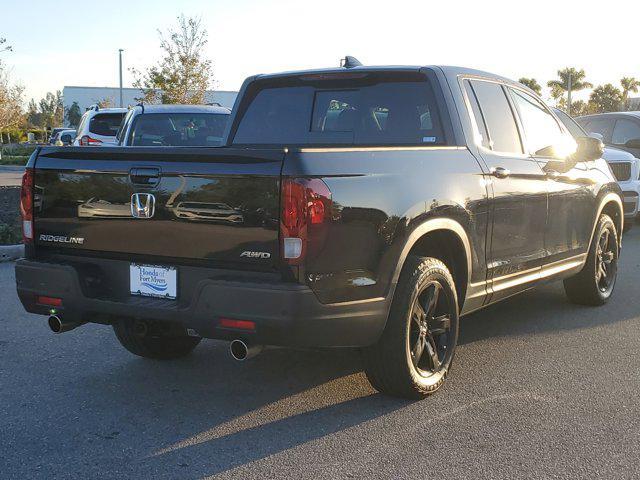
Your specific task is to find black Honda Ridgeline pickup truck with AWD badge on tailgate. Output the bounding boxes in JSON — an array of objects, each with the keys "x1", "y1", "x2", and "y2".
[{"x1": 16, "y1": 60, "x2": 623, "y2": 398}]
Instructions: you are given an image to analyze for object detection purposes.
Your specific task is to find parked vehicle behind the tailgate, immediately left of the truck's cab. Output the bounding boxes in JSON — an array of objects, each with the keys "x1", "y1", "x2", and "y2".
[{"x1": 116, "y1": 105, "x2": 231, "y2": 147}]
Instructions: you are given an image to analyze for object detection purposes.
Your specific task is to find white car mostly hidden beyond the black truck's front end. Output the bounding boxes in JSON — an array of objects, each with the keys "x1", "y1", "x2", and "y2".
[{"x1": 553, "y1": 108, "x2": 640, "y2": 224}]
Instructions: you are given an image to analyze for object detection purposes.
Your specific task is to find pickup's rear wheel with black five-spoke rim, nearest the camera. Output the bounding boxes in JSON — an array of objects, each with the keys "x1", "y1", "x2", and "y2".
[{"x1": 363, "y1": 256, "x2": 459, "y2": 399}]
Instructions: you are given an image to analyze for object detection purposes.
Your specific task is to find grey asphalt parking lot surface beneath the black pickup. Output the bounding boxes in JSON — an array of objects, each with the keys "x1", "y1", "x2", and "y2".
[{"x1": 0, "y1": 227, "x2": 640, "y2": 479}]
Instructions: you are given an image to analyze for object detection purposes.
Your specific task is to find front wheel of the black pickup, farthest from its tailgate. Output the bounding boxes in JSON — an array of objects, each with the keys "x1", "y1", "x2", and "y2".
[{"x1": 564, "y1": 213, "x2": 620, "y2": 306}]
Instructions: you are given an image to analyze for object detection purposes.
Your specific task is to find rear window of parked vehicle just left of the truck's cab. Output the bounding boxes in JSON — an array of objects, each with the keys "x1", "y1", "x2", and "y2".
[{"x1": 129, "y1": 113, "x2": 229, "y2": 147}]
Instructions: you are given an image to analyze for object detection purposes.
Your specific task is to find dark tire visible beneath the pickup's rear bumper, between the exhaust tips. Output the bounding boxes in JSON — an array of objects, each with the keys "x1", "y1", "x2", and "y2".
[{"x1": 113, "y1": 319, "x2": 201, "y2": 360}]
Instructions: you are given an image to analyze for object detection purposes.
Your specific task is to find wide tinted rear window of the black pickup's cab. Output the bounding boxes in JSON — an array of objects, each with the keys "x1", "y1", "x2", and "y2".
[{"x1": 232, "y1": 72, "x2": 445, "y2": 146}]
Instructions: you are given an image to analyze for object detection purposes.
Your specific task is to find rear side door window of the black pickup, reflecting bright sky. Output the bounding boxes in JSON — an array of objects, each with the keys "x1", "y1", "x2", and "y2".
[{"x1": 471, "y1": 80, "x2": 523, "y2": 154}]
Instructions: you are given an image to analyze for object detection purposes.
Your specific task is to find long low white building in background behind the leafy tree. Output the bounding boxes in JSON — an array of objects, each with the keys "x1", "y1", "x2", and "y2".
[{"x1": 62, "y1": 86, "x2": 238, "y2": 121}]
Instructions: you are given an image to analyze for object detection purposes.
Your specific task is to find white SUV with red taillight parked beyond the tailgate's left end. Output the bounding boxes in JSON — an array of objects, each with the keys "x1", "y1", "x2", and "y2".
[{"x1": 73, "y1": 105, "x2": 127, "y2": 147}]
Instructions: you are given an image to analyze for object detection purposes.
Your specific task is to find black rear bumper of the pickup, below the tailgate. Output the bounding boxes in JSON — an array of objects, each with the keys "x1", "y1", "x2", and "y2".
[{"x1": 16, "y1": 260, "x2": 389, "y2": 347}]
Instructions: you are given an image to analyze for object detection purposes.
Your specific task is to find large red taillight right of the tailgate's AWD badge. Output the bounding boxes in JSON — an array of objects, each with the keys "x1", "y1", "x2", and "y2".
[{"x1": 280, "y1": 178, "x2": 331, "y2": 265}]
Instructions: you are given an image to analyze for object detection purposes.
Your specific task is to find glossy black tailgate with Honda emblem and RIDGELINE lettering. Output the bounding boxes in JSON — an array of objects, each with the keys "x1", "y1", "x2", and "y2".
[{"x1": 34, "y1": 148, "x2": 284, "y2": 269}]
